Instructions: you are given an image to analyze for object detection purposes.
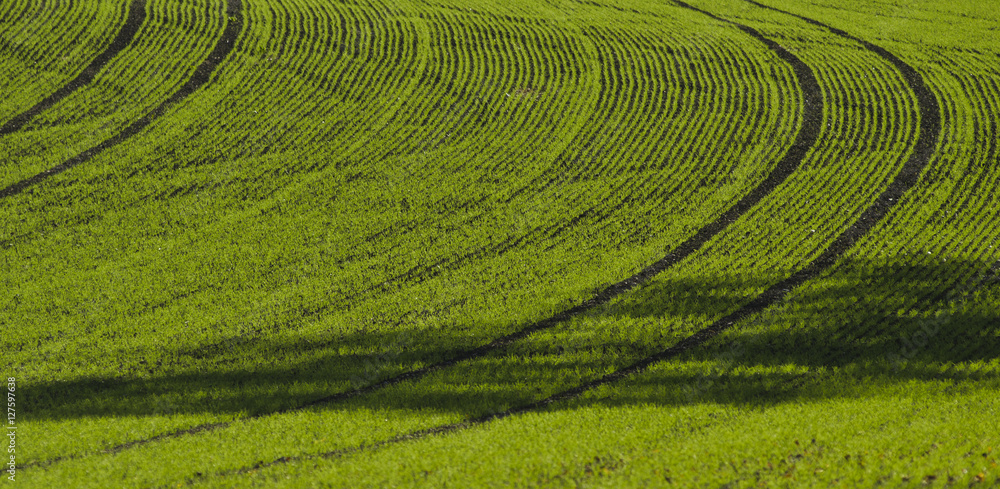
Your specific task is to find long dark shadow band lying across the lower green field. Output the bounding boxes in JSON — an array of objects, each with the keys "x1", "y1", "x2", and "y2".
[{"x1": 22, "y1": 257, "x2": 1000, "y2": 420}]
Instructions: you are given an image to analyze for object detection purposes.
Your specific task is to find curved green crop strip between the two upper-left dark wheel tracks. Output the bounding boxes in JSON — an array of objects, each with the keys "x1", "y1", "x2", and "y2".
[{"x1": 0, "y1": 0, "x2": 224, "y2": 193}]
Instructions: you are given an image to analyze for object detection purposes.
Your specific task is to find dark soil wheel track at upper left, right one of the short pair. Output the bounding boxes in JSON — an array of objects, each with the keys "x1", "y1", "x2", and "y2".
[{"x1": 0, "y1": 0, "x2": 243, "y2": 199}]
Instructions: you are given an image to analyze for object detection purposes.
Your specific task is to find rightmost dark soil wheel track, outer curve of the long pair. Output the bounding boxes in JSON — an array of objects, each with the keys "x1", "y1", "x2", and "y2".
[{"x1": 189, "y1": 0, "x2": 941, "y2": 480}]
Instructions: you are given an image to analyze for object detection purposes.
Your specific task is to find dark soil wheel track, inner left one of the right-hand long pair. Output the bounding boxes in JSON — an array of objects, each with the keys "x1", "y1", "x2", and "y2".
[{"x1": 33, "y1": 0, "x2": 823, "y2": 469}]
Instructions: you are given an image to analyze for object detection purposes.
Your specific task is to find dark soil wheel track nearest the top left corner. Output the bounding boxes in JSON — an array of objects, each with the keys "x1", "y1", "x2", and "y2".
[{"x1": 0, "y1": 0, "x2": 146, "y2": 137}]
